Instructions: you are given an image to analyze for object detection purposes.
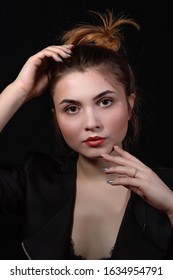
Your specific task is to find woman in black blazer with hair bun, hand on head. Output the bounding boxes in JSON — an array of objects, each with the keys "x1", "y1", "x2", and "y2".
[{"x1": 0, "y1": 12, "x2": 173, "y2": 259}]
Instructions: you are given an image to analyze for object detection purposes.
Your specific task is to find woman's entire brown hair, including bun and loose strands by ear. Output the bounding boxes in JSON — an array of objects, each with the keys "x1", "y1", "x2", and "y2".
[{"x1": 50, "y1": 10, "x2": 139, "y2": 153}]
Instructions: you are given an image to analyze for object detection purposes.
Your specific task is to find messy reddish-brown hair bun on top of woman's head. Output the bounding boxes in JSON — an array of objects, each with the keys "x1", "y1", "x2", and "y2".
[{"x1": 63, "y1": 10, "x2": 139, "y2": 51}]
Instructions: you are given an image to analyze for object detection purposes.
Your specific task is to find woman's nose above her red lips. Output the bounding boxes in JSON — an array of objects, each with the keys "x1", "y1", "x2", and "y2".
[{"x1": 85, "y1": 109, "x2": 102, "y2": 131}]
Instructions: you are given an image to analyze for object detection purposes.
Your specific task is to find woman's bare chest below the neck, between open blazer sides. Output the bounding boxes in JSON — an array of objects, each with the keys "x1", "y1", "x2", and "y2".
[{"x1": 72, "y1": 180, "x2": 129, "y2": 259}]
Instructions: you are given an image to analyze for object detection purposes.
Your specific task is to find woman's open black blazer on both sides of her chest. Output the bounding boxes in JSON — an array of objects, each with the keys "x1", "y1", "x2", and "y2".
[{"x1": 0, "y1": 153, "x2": 173, "y2": 260}]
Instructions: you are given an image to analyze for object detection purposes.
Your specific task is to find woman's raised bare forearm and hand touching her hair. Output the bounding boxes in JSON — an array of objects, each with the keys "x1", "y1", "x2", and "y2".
[{"x1": 0, "y1": 45, "x2": 72, "y2": 131}]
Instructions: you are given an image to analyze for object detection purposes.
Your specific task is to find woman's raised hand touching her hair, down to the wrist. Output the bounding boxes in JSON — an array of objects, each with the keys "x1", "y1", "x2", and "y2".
[{"x1": 14, "y1": 45, "x2": 72, "y2": 100}]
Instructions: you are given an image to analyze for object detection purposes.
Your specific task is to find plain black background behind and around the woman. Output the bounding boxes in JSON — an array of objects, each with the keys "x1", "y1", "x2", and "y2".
[{"x1": 0, "y1": 0, "x2": 173, "y2": 259}]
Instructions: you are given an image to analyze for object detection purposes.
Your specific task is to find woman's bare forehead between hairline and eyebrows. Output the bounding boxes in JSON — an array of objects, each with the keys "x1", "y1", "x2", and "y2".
[{"x1": 54, "y1": 69, "x2": 124, "y2": 100}]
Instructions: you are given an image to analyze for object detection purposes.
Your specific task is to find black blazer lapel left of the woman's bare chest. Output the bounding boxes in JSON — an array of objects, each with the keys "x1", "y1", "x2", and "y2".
[{"x1": 23, "y1": 191, "x2": 74, "y2": 260}]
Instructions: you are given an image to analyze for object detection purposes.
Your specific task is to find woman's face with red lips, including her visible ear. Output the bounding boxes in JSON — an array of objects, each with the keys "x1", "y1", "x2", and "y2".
[{"x1": 53, "y1": 70, "x2": 134, "y2": 158}]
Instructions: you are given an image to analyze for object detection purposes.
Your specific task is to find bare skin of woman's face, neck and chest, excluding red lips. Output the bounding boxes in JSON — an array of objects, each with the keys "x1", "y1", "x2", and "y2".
[{"x1": 53, "y1": 69, "x2": 135, "y2": 259}]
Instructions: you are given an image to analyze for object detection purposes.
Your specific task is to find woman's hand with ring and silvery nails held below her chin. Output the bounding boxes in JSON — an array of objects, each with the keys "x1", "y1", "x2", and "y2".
[{"x1": 102, "y1": 146, "x2": 173, "y2": 224}]
